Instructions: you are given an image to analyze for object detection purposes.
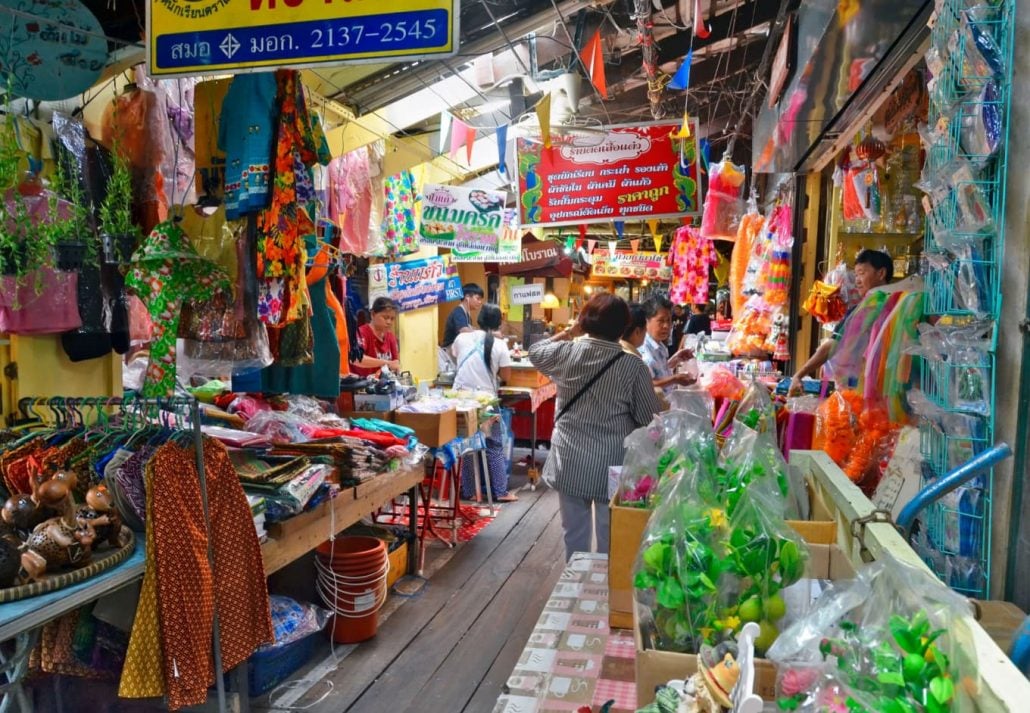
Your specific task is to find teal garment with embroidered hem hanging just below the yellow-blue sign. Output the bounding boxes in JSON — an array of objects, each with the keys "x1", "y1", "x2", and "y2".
[{"x1": 216, "y1": 72, "x2": 277, "y2": 220}]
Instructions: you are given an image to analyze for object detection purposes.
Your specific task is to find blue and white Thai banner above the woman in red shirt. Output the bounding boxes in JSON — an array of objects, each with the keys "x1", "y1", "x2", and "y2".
[{"x1": 369, "y1": 256, "x2": 461, "y2": 312}]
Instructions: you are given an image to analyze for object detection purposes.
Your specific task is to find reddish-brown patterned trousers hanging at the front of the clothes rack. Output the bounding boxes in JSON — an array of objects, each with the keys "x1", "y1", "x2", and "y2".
[{"x1": 119, "y1": 440, "x2": 274, "y2": 711}]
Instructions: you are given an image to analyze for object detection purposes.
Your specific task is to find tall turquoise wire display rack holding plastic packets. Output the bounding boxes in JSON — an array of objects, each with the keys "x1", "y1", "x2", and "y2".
[{"x1": 921, "y1": 0, "x2": 1017, "y2": 598}]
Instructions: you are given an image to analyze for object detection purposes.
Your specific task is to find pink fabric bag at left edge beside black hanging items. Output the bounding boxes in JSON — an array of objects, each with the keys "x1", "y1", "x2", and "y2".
[{"x1": 0, "y1": 268, "x2": 82, "y2": 334}]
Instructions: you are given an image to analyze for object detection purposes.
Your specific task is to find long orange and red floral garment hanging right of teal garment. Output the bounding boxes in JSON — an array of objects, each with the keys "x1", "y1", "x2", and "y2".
[{"x1": 258, "y1": 70, "x2": 330, "y2": 327}]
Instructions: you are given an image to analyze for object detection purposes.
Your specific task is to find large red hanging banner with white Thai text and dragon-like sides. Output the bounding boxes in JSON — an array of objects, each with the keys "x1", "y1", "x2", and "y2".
[{"x1": 516, "y1": 118, "x2": 701, "y2": 227}]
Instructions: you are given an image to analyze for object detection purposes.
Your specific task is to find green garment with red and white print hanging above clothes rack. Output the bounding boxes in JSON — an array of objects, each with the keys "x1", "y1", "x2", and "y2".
[{"x1": 126, "y1": 223, "x2": 232, "y2": 397}]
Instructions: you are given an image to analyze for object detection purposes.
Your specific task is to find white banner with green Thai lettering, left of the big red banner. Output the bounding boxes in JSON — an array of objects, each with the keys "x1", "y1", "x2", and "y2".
[{"x1": 421, "y1": 183, "x2": 508, "y2": 252}]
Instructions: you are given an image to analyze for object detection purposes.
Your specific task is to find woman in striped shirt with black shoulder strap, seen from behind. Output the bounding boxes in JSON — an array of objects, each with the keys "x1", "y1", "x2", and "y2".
[{"x1": 529, "y1": 293, "x2": 660, "y2": 559}]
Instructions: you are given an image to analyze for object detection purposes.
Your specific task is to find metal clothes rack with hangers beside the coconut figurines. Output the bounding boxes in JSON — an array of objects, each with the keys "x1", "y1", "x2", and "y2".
[{"x1": 18, "y1": 396, "x2": 228, "y2": 713}]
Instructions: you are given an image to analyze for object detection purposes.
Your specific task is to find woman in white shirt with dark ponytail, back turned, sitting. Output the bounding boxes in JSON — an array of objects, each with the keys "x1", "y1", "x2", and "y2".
[{"x1": 451, "y1": 304, "x2": 518, "y2": 503}]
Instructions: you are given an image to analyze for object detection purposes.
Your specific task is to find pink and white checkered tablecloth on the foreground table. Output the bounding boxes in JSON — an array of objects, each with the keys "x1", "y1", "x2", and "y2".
[{"x1": 493, "y1": 553, "x2": 637, "y2": 713}]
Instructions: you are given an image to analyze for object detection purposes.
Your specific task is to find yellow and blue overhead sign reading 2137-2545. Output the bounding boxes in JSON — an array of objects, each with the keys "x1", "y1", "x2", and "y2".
[{"x1": 146, "y1": 0, "x2": 458, "y2": 76}]
